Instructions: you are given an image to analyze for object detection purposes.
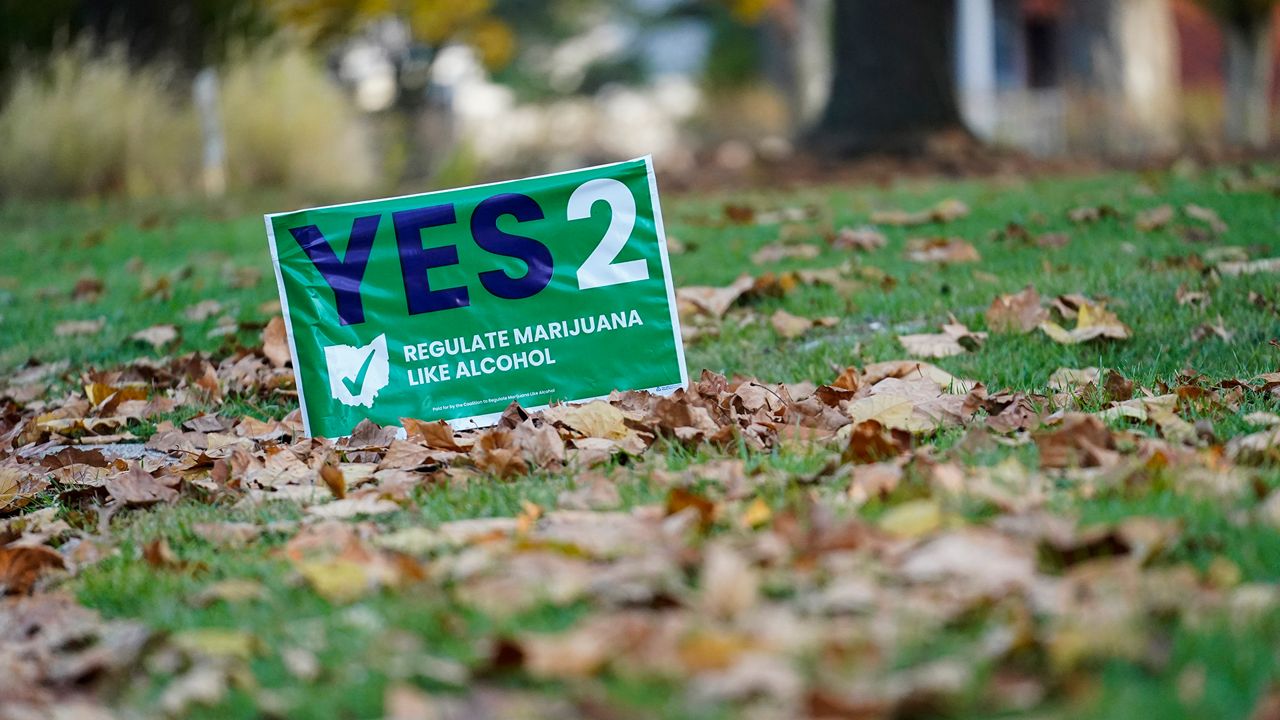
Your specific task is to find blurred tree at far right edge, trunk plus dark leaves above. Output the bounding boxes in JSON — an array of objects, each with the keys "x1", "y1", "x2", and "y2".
[{"x1": 1197, "y1": 0, "x2": 1280, "y2": 147}]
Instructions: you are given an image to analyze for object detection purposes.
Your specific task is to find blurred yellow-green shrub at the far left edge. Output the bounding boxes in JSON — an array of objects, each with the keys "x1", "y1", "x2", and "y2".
[{"x1": 0, "y1": 45, "x2": 198, "y2": 196}]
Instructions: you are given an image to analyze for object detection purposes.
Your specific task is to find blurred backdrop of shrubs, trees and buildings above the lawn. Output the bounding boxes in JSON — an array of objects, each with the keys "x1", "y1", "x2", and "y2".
[{"x1": 0, "y1": 0, "x2": 1280, "y2": 199}]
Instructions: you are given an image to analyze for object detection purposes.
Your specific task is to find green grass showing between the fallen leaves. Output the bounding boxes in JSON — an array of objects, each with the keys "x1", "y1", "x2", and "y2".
[{"x1": 0, "y1": 163, "x2": 1280, "y2": 717}]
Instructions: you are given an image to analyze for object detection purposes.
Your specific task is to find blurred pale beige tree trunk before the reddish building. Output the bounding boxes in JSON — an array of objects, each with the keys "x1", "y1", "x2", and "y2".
[{"x1": 1066, "y1": 0, "x2": 1180, "y2": 156}]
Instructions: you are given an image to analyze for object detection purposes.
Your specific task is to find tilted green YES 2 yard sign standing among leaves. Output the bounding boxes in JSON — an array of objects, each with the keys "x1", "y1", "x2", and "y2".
[{"x1": 266, "y1": 158, "x2": 689, "y2": 437}]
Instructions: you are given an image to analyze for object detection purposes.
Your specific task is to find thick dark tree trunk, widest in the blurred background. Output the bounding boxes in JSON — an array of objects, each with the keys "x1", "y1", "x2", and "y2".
[{"x1": 809, "y1": 0, "x2": 964, "y2": 155}]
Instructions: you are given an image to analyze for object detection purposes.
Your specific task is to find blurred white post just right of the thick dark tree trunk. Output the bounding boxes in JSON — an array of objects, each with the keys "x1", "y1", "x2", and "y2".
[{"x1": 956, "y1": 0, "x2": 997, "y2": 140}]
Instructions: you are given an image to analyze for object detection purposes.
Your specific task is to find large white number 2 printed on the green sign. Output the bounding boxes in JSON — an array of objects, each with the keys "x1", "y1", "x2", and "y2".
[{"x1": 568, "y1": 178, "x2": 649, "y2": 290}]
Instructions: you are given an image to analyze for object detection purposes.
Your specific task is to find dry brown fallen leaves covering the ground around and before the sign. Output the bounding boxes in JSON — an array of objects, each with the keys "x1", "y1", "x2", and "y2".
[{"x1": 0, "y1": 311, "x2": 1280, "y2": 717}]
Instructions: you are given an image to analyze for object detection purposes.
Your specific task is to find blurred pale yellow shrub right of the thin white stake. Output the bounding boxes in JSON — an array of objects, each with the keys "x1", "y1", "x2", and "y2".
[{"x1": 221, "y1": 46, "x2": 374, "y2": 191}]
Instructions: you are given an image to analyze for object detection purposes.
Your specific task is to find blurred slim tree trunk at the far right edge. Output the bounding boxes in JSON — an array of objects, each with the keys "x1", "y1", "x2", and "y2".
[{"x1": 1224, "y1": 13, "x2": 1274, "y2": 147}]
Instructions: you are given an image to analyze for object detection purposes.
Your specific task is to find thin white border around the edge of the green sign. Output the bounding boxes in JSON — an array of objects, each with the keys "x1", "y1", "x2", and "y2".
[{"x1": 262, "y1": 155, "x2": 689, "y2": 439}]
